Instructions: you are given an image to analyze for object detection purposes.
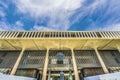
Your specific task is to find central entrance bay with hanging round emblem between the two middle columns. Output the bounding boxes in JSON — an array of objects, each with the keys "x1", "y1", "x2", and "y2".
[{"x1": 47, "y1": 50, "x2": 74, "y2": 80}]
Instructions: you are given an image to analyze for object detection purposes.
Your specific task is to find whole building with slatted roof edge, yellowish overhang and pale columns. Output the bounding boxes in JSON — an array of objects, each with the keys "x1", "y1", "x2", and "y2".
[{"x1": 0, "y1": 31, "x2": 120, "y2": 80}]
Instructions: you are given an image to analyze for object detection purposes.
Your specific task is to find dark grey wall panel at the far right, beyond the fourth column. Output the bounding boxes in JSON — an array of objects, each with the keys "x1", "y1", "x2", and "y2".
[{"x1": 99, "y1": 50, "x2": 120, "y2": 72}]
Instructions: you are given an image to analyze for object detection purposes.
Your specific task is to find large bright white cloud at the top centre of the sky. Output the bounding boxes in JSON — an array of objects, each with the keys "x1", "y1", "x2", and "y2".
[{"x1": 14, "y1": 0, "x2": 83, "y2": 30}]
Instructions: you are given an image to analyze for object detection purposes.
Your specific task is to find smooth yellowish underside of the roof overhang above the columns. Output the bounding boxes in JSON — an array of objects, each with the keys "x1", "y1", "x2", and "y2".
[{"x1": 0, "y1": 38, "x2": 120, "y2": 50}]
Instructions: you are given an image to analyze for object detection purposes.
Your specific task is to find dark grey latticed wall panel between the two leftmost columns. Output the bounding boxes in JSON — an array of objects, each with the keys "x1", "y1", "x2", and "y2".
[{"x1": 18, "y1": 50, "x2": 46, "y2": 68}]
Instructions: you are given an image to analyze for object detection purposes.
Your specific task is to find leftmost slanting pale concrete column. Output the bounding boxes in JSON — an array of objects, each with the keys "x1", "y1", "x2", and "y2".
[{"x1": 10, "y1": 48, "x2": 25, "y2": 75}]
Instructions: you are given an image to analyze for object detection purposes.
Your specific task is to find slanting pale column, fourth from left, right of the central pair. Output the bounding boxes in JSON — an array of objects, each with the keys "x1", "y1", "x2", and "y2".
[{"x1": 95, "y1": 48, "x2": 109, "y2": 74}]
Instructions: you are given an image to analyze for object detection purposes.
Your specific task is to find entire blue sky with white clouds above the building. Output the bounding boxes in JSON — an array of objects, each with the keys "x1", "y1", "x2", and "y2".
[{"x1": 0, "y1": 0, "x2": 120, "y2": 31}]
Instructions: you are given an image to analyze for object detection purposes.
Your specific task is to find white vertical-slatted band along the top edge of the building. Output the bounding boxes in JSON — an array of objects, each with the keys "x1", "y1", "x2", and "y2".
[{"x1": 0, "y1": 31, "x2": 120, "y2": 38}]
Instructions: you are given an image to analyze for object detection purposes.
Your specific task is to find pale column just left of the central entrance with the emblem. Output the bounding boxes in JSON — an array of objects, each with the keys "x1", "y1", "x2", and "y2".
[{"x1": 42, "y1": 49, "x2": 49, "y2": 80}]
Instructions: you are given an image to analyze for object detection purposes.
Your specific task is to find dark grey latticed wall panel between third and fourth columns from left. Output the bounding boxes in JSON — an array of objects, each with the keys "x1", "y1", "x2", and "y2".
[{"x1": 74, "y1": 50, "x2": 101, "y2": 68}]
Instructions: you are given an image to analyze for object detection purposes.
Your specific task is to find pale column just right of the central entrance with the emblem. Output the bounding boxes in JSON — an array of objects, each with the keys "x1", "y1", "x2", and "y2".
[{"x1": 71, "y1": 49, "x2": 80, "y2": 80}]
